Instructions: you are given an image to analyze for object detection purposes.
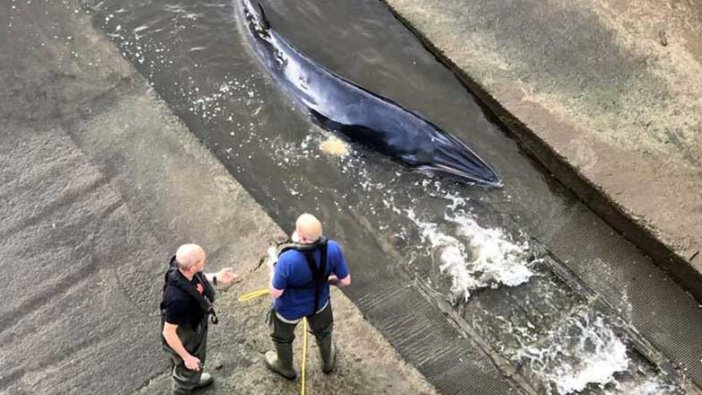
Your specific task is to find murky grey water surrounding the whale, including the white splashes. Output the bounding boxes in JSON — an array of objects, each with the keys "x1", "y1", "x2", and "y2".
[{"x1": 86, "y1": 0, "x2": 692, "y2": 394}]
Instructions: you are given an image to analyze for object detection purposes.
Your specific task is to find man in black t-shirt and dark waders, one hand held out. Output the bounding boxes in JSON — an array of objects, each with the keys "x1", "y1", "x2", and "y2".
[{"x1": 161, "y1": 244, "x2": 239, "y2": 394}]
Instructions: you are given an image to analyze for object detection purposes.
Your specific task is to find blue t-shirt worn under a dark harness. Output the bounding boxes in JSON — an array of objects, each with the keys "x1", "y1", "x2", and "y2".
[{"x1": 273, "y1": 240, "x2": 349, "y2": 320}]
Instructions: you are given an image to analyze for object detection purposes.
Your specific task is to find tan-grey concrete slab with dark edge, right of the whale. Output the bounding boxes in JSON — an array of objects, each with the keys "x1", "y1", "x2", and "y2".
[{"x1": 386, "y1": 0, "x2": 702, "y2": 292}]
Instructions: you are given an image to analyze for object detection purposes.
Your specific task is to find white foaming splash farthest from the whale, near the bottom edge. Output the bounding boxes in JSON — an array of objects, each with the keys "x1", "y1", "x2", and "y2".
[{"x1": 519, "y1": 315, "x2": 629, "y2": 395}]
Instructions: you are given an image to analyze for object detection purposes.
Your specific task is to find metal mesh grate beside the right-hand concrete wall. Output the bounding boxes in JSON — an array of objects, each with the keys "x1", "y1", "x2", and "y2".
[{"x1": 544, "y1": 209, "x2": 702, "y2": 386}]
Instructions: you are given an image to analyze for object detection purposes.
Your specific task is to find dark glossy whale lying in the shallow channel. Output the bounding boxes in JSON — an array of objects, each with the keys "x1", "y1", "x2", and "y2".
[{"x1": 236, "y1": 0, "x2": 503, "y2": 188}]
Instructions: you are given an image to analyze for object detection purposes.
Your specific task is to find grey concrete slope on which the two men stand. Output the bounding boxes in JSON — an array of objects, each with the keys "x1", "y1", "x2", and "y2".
[{"x1": 0, "y1": 1, "x2": 434, "y2": 394}]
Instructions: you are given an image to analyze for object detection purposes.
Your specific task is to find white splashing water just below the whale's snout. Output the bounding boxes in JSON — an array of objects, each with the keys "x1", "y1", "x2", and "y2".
[{"x1": 406, "y1": 210, "x2": 533, "y2": 301}]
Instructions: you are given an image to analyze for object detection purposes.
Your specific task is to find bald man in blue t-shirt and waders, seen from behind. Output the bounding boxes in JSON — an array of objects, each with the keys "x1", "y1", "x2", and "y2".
[{"x1": 266, "y1": 214, "x2": 351, "y2": 380}]
